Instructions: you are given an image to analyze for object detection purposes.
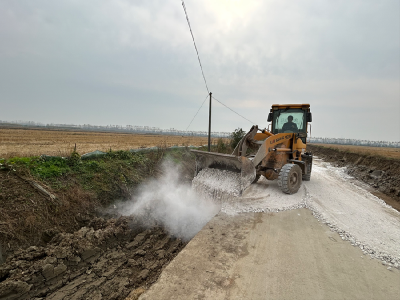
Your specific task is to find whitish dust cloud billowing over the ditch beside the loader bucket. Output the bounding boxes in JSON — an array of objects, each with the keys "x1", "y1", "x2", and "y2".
[{"x1": 119, "y1": 161, "x2": 220, "y2": 241}]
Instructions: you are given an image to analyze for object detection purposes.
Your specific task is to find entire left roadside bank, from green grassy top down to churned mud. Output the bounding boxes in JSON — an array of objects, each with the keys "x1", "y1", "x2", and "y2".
[{"x1": 0, "y1": 148, "x2": 198, "y2": 300}]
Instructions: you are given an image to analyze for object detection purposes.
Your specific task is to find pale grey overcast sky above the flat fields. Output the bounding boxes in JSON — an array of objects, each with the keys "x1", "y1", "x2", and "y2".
[{"x1": 0, "y1": 0, "x2": 400, "y2": 141}]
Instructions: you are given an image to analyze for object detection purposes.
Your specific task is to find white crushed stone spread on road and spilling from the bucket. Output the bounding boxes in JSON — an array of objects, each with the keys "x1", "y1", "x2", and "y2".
[{"x1": 194, "y1": 158, "x2": 400, "y2": 269}]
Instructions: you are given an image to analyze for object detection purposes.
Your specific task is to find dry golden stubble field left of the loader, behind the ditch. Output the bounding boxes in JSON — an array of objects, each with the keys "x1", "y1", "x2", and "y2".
[{"x1": 0, "y1": 128, "x2": 223, "y2": 158}]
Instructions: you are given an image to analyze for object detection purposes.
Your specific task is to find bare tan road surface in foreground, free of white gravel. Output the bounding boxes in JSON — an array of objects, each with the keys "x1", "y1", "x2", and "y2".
[{"x1": 140, "y1": 209, "x2": 400, "y2": 300}]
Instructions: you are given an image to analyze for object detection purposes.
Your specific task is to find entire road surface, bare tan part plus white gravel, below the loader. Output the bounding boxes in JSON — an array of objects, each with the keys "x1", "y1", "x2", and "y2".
[{"x1": 140, "y1": 160, "x2": 400, "y2": 300}]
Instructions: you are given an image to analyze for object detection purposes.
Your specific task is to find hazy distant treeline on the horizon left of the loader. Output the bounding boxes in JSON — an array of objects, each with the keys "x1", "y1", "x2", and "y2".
[{"x1": 0, "y1": 120, "x2": 231, "y2": 138}]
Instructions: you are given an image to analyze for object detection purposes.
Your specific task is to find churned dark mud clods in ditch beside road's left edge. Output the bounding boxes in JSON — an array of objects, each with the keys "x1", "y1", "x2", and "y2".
[{"x1": 0, "y1": 217, "x2": 184, "y2": 300}]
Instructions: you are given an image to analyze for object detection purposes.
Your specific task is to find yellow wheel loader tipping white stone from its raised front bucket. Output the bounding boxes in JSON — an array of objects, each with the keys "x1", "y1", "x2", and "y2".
[{"x1": 191, "y1": 104, "x2": 312, "y2": 194}]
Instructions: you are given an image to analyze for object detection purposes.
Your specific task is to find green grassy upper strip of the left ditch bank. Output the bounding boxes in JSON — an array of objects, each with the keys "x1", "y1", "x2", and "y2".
[{"x1": 0, "y1": 151, "x2": 153, "y2": 205}]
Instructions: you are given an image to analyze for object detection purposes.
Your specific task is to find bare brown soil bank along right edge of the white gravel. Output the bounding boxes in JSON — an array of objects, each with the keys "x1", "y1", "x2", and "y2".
[{"x1": 307, "y1": 144, "x2": 400, "y2": 210}]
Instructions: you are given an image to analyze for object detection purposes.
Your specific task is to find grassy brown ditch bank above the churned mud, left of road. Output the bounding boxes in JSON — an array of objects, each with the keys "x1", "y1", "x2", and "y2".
[{"x1": 0, "y1": 148, "x2": 194, "y2": 255}]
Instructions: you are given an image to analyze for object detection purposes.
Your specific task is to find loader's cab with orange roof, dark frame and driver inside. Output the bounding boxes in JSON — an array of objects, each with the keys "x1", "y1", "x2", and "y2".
[{"x1": 268, "y1": 104, "x2": 312, "y2": 143}]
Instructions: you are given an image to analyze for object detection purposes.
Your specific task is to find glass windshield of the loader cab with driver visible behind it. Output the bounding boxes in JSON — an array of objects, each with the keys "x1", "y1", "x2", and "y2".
[{"x1": 272, "y1": 108, "x2": 306, "y2": 134}]
